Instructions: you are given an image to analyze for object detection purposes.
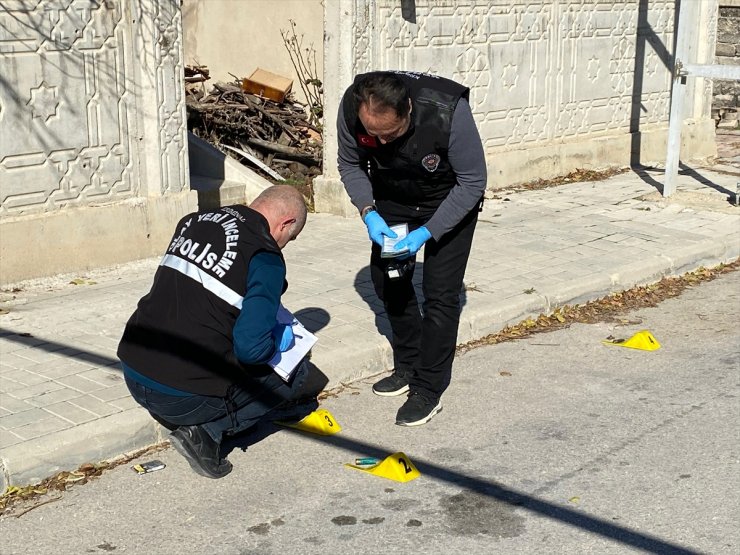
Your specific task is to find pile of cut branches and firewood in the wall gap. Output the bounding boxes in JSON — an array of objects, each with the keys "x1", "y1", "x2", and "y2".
[{"x1": 185, "y1": 66, "x2": 322, "y2": 183}]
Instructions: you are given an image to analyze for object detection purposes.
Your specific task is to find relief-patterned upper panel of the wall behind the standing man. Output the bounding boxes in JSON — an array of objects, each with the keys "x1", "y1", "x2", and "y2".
[{"x1": 354, "y1": 0, "x2": 675, "y2": 152}]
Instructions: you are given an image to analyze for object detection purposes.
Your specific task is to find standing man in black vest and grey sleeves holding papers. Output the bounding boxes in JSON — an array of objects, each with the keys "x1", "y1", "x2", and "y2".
[{"x1": 337, "y1": 71, "x2": 486, "y2": 426}]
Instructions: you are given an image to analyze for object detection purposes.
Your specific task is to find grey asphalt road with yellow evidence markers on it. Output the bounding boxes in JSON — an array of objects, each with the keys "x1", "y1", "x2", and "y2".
[{"x1": 0, "y1": 272, "x2": 740, "y2": 555}]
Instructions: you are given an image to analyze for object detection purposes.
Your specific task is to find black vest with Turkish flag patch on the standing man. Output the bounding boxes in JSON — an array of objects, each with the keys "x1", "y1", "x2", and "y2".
[{"x1": 342, "y1": 71, "x2": 470, "y2": 208}]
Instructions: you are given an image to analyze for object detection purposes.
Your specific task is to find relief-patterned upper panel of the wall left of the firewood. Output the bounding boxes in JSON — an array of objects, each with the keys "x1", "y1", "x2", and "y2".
[{"x1": 0, "y1": 0, "x2": 187, "y2": 215}]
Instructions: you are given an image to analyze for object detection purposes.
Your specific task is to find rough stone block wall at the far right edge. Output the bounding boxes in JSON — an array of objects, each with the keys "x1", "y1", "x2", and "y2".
[{"x1": 712, "y1": 0, "x2": 740, "y2": 128}]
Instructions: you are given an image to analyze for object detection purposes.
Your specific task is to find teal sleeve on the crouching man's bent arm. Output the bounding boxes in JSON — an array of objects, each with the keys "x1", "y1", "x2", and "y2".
[{"x1": 233, "y1": 252, "x2": 285, "y2": 364}]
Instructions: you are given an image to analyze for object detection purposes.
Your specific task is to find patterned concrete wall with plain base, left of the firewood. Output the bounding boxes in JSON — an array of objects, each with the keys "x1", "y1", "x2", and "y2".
[{"x1": 0, "y1": 0, "x2": 193, "y2": 283}]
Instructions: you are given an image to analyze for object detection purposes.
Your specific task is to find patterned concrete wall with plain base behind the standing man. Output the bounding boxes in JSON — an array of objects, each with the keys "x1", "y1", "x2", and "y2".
[{"x1": 317, "y1": 0, "x2": 716, "y2": 213}]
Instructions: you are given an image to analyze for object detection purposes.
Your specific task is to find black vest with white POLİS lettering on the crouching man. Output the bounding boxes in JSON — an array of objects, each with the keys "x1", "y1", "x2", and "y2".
[{"x1": 118, "y1": 205, "x2": 287, "y2": 396}]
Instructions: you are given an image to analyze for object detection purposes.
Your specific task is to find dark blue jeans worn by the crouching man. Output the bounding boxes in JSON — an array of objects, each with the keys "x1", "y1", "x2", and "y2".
[{"x1": 124, "y1": 362, "x2": 308, "y2": 443}]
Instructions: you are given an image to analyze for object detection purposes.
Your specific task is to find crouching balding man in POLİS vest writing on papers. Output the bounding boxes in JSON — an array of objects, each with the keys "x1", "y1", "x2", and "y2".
[{"x1": 118, "y1": 185, "x2": 306, "y2": 478}]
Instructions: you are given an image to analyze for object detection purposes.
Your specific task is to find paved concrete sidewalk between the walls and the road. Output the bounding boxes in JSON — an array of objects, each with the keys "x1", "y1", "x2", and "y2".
[{"x1": 0, "y1": 167, "x2": 740, "y2": 489}]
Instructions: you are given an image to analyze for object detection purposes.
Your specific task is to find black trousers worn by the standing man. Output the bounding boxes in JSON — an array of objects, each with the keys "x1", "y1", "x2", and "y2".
[{"x1": 370, "y1": 202, "x2": 478, "y2": 397}]
